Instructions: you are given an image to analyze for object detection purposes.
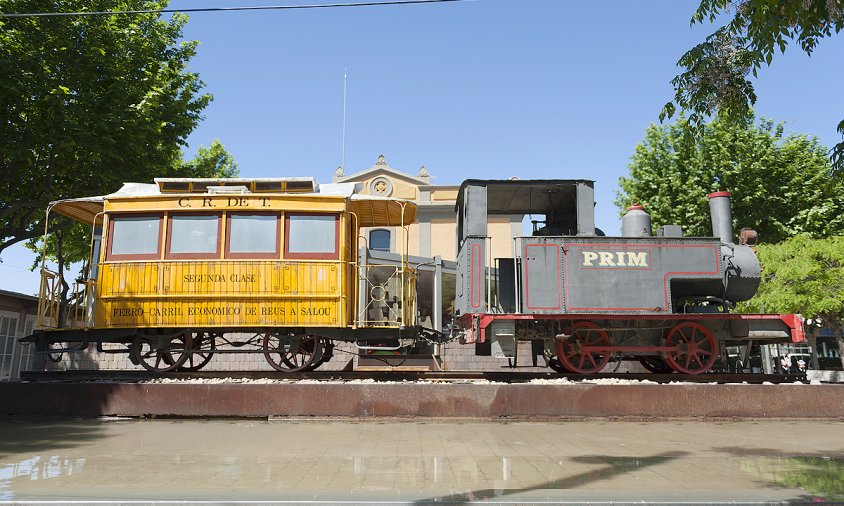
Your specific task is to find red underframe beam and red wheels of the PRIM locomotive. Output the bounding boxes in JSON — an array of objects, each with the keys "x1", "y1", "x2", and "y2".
[{"x1": 458, "y1": 313, "x2": 806, "y2": 374}]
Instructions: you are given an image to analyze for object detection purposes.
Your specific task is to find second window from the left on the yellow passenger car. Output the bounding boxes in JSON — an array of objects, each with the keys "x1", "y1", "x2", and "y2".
[{"x1": 167, "y1": 214, "x2": 220, "y2": 258}]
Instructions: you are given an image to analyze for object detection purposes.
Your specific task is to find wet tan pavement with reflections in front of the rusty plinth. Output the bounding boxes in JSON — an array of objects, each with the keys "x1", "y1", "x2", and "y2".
[{"x1": 0, "y1": 420, "x2": 844, "y2": 504}]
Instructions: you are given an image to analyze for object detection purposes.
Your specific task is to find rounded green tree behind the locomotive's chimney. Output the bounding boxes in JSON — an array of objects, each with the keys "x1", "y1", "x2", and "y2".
[{"x1": 615, "y1": 116, "x2": 844, "y2": 242}]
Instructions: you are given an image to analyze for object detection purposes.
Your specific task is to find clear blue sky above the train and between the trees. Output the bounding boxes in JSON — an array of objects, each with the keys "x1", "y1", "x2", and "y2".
[{"x1": 0, "y1": 0, "x2": 844, "y2": 294}]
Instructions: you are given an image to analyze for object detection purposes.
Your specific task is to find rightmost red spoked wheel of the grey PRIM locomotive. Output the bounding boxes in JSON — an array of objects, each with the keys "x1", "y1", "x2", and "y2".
[{"x1": 665, "y1": 322, "x2": 718, "y2": 374}]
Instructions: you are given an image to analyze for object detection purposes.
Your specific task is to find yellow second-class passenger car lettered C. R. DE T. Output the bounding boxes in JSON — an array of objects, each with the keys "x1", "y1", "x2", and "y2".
[{"x1": 31, "y1": 178, "x2": 416, "y2": 372}]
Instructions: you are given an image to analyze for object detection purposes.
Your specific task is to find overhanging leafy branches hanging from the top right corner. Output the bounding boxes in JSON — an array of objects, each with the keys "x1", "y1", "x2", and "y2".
[{"x1": 660, "y1": 0, "x2": 844, "y2": 170}]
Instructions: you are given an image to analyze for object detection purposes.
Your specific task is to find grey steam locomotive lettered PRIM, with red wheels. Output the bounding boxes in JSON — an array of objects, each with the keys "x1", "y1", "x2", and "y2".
[{"x1": 455, "y1": 180, "x2": 804, "y2": 374}]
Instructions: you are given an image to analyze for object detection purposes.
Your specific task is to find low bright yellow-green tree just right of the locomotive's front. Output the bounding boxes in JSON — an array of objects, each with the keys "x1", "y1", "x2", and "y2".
[{"x1": 739, "y1": 234, "x2": 844, "y2": 364}]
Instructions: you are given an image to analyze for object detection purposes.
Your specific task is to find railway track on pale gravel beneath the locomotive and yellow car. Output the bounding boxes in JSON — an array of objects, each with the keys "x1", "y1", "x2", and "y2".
[{"x1": 21, "y1": 371, "x2": 808, "y2": 384}]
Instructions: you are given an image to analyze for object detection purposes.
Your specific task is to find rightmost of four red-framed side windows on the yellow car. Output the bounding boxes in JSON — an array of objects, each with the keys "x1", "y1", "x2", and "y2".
[{"x1": 284, "y1": 214, "x2": 340, "y2": 259}]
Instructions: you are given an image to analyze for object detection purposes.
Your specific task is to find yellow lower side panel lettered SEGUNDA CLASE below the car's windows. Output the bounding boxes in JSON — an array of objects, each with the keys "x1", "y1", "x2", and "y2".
[{"x1": 95, "y1": 261, "x2": 347, "y2": 328}]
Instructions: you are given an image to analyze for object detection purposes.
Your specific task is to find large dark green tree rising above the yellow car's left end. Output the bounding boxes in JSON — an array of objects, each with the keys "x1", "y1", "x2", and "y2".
[{"x1": 0, "y1": 0, "x2": 211, "y2": 252}]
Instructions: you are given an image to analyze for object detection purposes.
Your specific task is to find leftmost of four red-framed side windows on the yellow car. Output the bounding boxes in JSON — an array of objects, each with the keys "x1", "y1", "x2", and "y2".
[{"x1": 108, "y1": 215, "x2": 161, "y2": 260}]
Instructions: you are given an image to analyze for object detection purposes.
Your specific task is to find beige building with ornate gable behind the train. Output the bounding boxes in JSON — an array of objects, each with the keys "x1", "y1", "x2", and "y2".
[{"x1": 333, "y1": 155, "x2": 523, "y2": 260}]
